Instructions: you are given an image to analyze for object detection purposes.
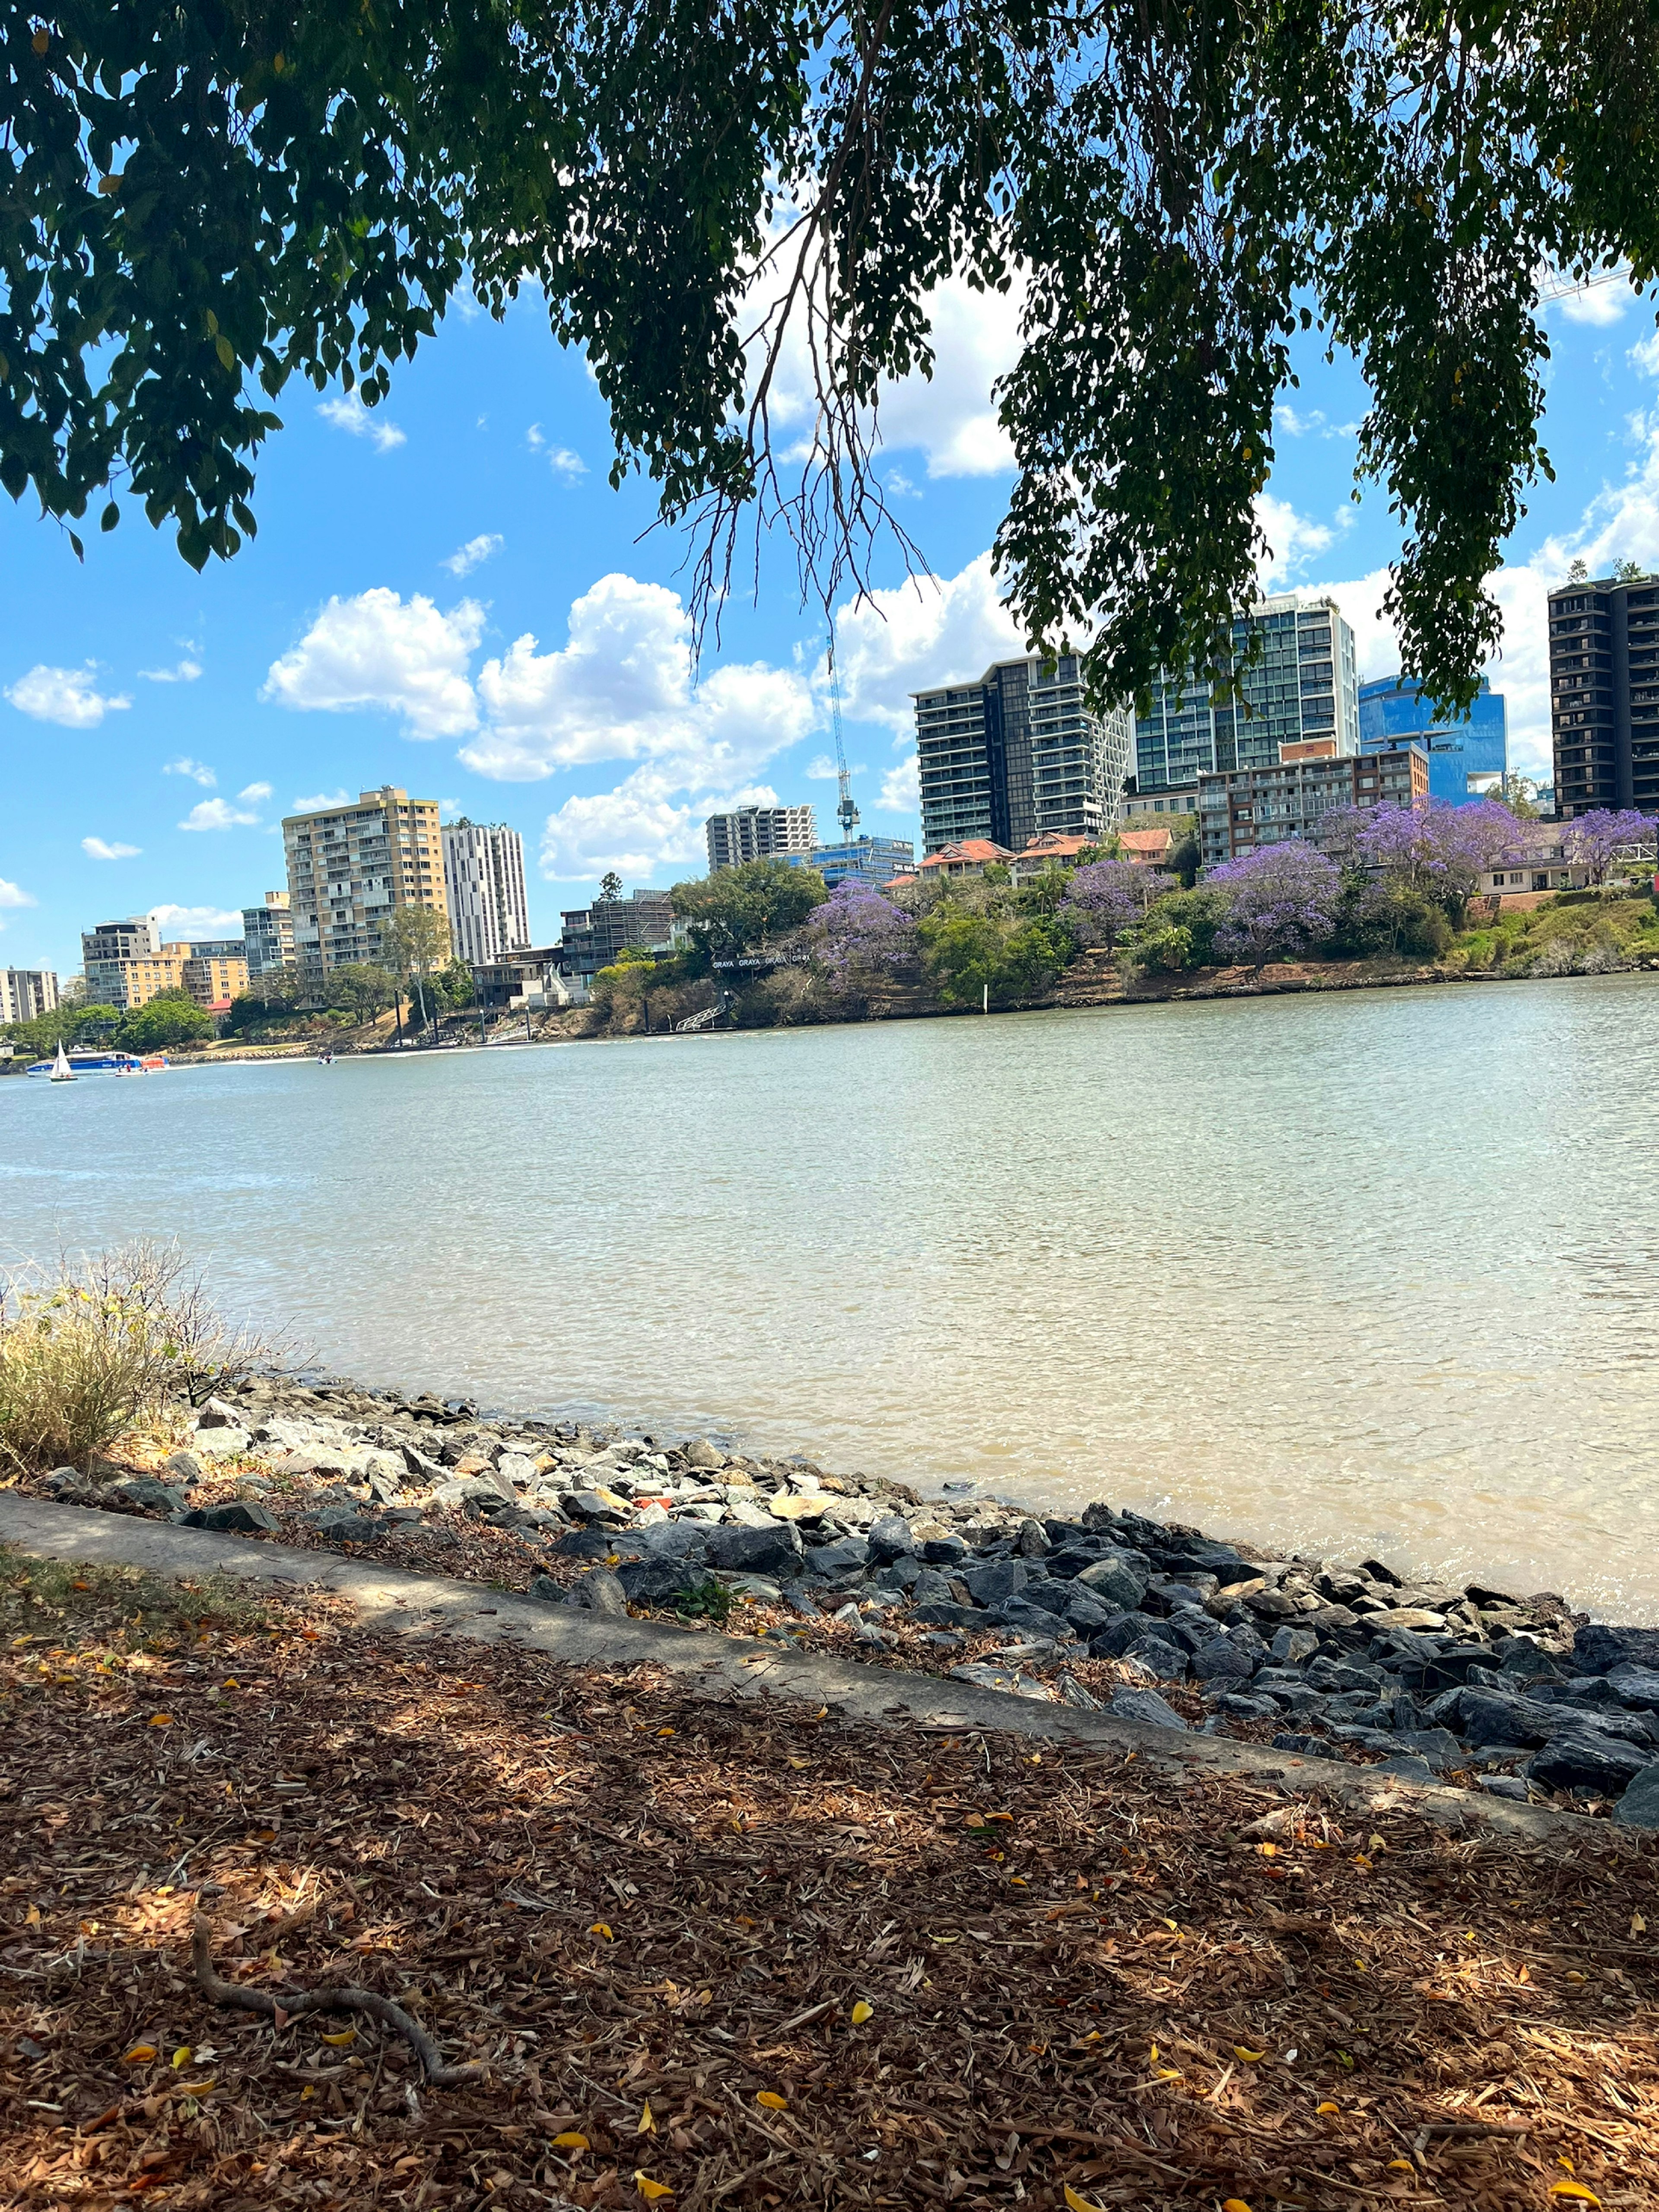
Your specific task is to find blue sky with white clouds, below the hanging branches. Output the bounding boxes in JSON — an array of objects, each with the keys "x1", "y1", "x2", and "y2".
[{"x1": 0, "y1": 265, "x2": 1659, "y2": 973}]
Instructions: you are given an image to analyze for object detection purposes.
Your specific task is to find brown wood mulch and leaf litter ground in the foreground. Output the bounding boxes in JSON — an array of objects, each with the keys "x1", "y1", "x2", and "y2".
[{"x1": 0, "y1": 1560, "x2": 1659, "y2": 2212}]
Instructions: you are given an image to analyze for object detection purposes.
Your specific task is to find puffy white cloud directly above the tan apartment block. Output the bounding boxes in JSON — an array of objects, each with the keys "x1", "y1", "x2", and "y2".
[{"x1": 261, "y1": 586, "x2": 484, "y2": 737}]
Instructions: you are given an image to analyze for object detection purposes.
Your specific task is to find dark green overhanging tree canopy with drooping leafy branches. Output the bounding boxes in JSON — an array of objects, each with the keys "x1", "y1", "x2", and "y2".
[{"x1": 0, "y1": 0, "x2": 1659, "y2": 706}]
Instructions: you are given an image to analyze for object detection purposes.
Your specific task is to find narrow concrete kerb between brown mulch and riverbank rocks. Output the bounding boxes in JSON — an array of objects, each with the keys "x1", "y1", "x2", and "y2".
[{"x1": 0, "y1": 1493, "x2": 1610, "y2": 1849}]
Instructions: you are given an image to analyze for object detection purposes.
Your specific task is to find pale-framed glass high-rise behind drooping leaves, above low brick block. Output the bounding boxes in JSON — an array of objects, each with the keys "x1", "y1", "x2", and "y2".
[{"x1": 1135, "y1": 593, "x2": 1360, "y2": 791}]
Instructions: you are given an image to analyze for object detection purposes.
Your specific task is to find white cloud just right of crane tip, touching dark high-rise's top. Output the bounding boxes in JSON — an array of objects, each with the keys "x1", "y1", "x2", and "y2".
[{"x1": 836, "y1": 553, "x2": 1024, "y2": 737}]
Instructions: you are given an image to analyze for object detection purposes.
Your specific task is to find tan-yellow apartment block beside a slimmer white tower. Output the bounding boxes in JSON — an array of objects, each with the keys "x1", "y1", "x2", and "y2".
[{"x1": 283, "y1": 783, "x2": 449, "y2": 980}]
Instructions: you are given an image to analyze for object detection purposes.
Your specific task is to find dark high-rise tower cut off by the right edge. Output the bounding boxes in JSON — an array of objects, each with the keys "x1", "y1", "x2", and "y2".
[{"x1": 1551, "y1": 575, "x2": 1659, "y2": 818}]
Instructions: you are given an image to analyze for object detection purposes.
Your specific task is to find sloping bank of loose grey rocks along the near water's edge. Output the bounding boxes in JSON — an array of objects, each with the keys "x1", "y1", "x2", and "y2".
[{"x1": 29, "y1": 1378, "x2": 1659, "y2": 1827}]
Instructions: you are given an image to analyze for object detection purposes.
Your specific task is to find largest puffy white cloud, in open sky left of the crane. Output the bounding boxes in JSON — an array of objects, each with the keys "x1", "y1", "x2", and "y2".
[{"x1": 460, "y1": 575, "x2": 816, "y2": 788}]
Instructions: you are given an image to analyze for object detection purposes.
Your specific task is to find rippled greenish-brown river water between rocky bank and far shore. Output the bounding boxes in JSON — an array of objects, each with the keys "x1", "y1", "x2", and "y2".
[{"x1": 0, "y1": 976, "x2": 1659, "y2": 1621}]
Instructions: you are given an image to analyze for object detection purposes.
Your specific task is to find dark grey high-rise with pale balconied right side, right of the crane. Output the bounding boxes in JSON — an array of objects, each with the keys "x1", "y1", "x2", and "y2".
[{"x1": 911, "y1": 655, "x2": 1132, "y2": 854}]
